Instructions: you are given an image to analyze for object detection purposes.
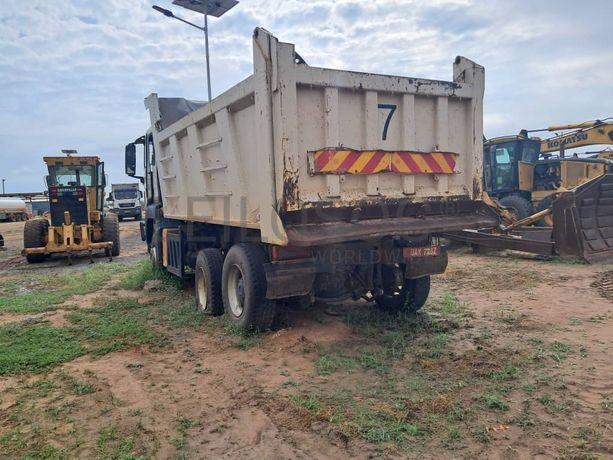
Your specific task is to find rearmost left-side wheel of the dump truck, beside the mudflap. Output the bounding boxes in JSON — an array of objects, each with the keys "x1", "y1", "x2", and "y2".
[{"x1": 221, "y1": 243, "x2": 276, "y2": 331}]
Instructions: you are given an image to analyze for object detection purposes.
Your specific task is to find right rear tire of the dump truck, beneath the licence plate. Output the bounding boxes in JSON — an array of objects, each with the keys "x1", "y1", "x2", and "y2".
[{"x1": 375, "y1": 265, "x2": 430, "y2": 313}]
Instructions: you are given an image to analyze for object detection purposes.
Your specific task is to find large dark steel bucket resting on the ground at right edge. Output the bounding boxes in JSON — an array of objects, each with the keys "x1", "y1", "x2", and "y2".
[{"x1": 552, "y1": 174, "x2": 613, "y2": 262}]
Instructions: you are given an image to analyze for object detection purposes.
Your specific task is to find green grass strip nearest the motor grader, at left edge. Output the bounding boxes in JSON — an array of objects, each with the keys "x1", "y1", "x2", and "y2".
[{"x1": 0, "y1": 263, "x2": 131, "y2": 314}]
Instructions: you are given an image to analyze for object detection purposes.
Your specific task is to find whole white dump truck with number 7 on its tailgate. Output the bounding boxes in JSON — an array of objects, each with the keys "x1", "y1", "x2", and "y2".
[{"x1": 125, "y1": 28, "x2": 496, "y2": 329}]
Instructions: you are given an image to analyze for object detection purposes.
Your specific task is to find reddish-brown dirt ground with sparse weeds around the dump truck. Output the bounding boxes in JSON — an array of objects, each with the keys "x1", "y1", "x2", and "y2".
[{"x1": 0, "y1": 222, "x2": 613, "y2": 459}]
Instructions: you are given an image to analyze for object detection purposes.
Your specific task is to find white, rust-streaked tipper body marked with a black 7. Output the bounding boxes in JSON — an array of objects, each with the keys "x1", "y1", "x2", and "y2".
[{"x1": 145, "y1": 29, "x2": 484, "y2": 246}]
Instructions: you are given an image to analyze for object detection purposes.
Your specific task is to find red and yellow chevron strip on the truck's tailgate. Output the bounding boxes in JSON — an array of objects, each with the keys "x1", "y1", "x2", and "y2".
[{"x1": 309, "y1": 149, "x2": 458, "y2": 174}]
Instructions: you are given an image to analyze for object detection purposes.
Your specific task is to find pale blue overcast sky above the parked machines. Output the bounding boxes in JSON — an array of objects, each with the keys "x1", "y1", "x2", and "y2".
[{"x1": 0, "y1": 0, "x2": 613, "y2": 193}]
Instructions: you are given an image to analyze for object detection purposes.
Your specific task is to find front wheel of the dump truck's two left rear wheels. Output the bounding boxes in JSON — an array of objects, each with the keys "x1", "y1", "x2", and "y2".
[{"x1": 195, "y1": 248, "x2": 223, "y2": 316}]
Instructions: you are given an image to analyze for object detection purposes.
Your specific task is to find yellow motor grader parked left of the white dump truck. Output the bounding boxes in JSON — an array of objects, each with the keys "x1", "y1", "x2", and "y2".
[{"x1": 23, "y1": 150, "x2": 120, "y2": 263}]
